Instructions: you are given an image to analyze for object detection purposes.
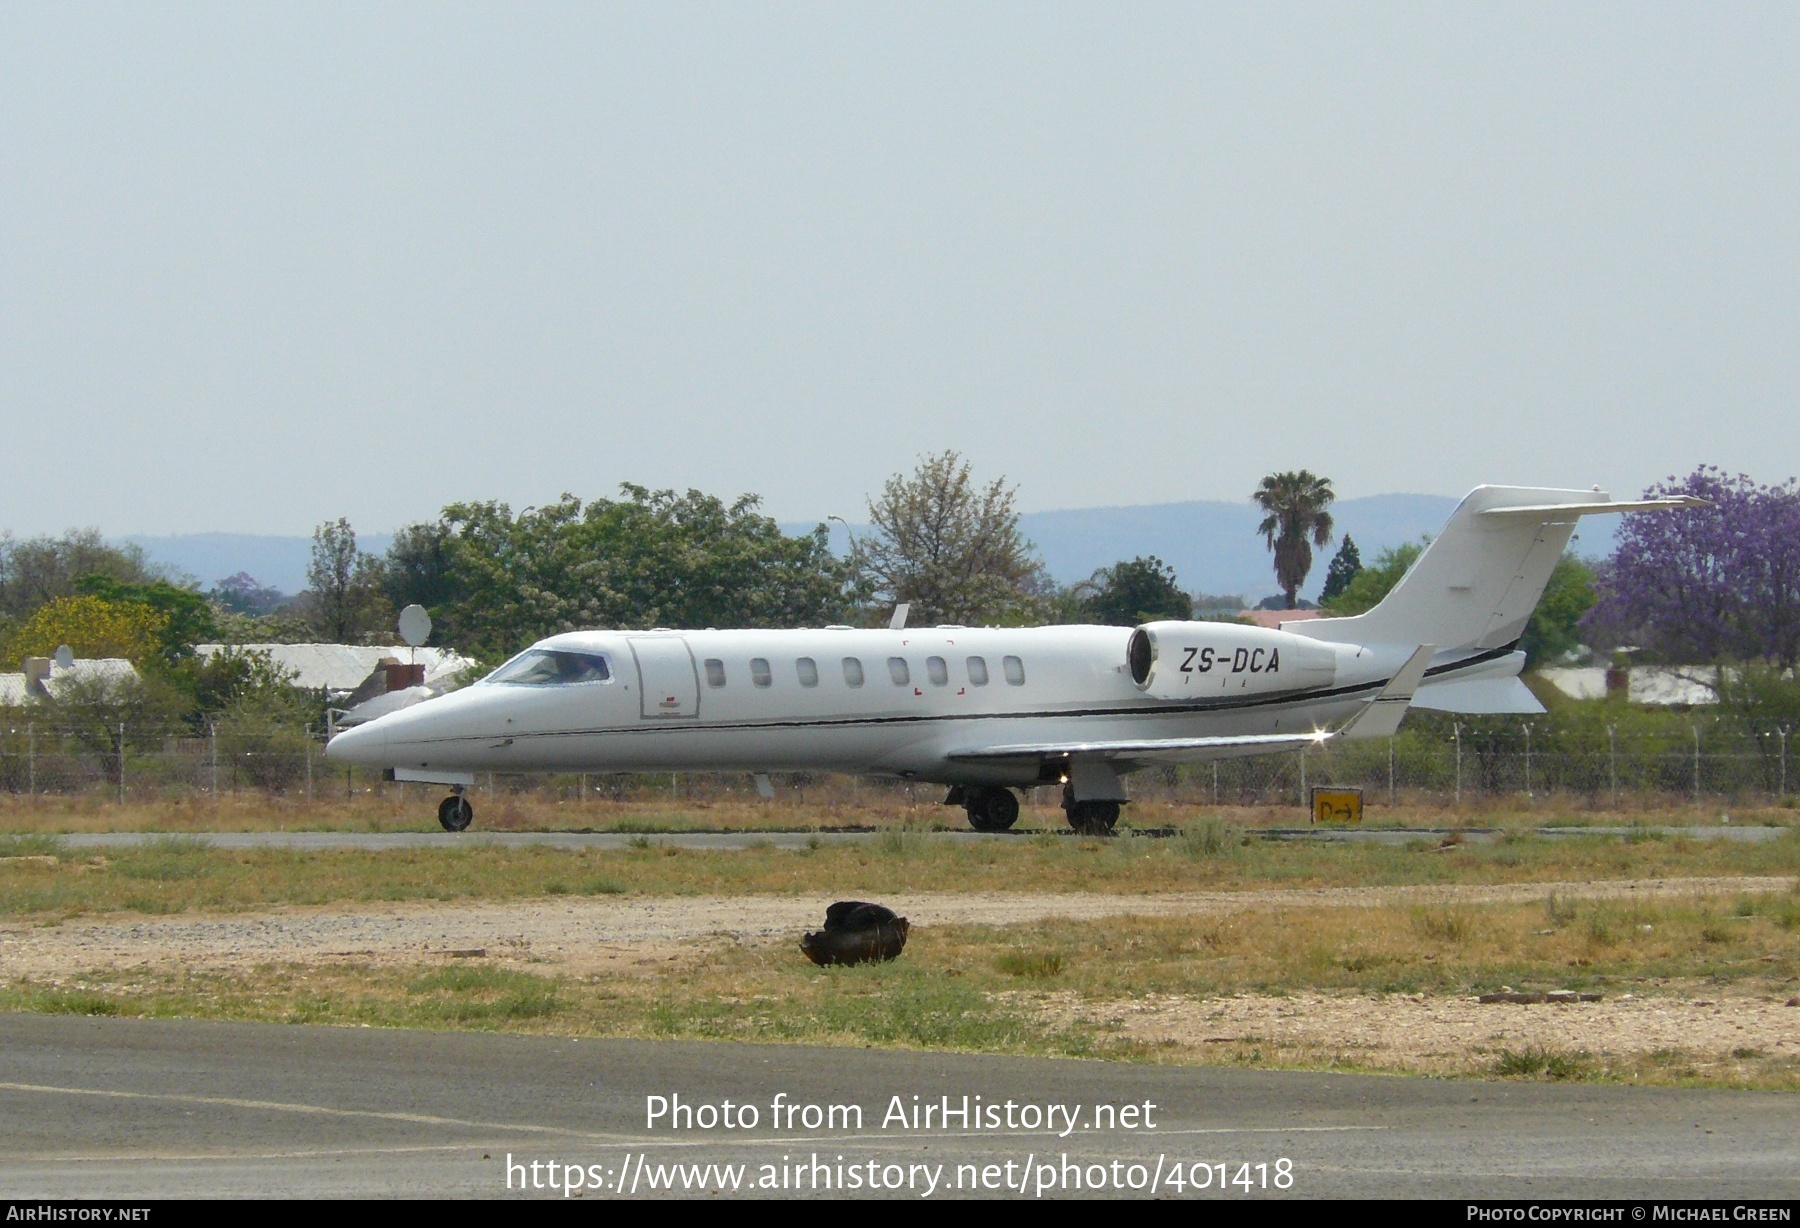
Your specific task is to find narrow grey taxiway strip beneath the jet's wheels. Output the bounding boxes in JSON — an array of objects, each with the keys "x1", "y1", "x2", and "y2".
[{"x1": 49, "y1": 826, "x2": 1791, "y2": 852}]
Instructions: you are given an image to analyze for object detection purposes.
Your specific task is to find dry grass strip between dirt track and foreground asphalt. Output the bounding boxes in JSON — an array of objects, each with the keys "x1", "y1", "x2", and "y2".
[{"x1": 0, "y1": 878, "x2": 1800, "y2": 1089}]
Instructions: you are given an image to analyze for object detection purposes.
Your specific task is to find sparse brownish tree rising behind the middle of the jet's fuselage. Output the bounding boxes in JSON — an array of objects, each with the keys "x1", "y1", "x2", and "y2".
[{"x1": 850, "y1": 452, "x2": 1040, "y2": 625}]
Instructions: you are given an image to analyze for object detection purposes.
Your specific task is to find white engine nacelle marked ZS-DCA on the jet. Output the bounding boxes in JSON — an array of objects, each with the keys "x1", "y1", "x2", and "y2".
[{"x1": 1125, "y1": 621, "x2": 1337, "y2": 699}]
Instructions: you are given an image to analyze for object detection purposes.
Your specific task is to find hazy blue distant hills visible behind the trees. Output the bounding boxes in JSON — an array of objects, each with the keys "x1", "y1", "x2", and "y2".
[{"x1": 122, "y1": 495, "x2": 1456, "y2": 605}]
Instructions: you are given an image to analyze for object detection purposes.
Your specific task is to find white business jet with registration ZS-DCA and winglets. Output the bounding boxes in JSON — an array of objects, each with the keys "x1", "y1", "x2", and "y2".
[{"x1": 326, "y1": 486, "x2": 1705, "y2": 834}]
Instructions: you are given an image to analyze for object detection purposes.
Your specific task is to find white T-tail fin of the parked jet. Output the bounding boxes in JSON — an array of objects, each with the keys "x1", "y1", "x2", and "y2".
[{"x1": 1282, "y1": 486, "x2": 1705, "y2": 654}]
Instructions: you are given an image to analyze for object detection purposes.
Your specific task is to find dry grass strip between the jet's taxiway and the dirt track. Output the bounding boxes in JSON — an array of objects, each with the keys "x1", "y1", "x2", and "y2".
[{"x1": 0, "y1": 828, "x2": 1800, "y2": 918}]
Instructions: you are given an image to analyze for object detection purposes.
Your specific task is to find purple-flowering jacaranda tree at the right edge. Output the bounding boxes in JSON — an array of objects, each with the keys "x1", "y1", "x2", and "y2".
[{"x1": 1584, "y1": 466, "x2": 1800, "y2": 668}]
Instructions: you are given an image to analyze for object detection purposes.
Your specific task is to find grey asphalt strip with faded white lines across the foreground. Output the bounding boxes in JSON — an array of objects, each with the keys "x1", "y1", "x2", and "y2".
[{"x1": 0, "y1": 1016, "x2": 1800, "y2": 1199}]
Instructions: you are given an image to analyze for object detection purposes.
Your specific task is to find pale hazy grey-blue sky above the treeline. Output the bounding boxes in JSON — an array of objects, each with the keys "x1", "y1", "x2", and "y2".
[{"x1": 0, "y1": 0, "x2": 1800, "y2": 533}]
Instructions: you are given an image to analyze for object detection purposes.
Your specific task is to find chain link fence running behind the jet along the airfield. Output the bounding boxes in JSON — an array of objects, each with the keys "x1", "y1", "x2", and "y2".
[{"x1": 0, "y1": 717, "x2": 1800, "y2": 807}]
